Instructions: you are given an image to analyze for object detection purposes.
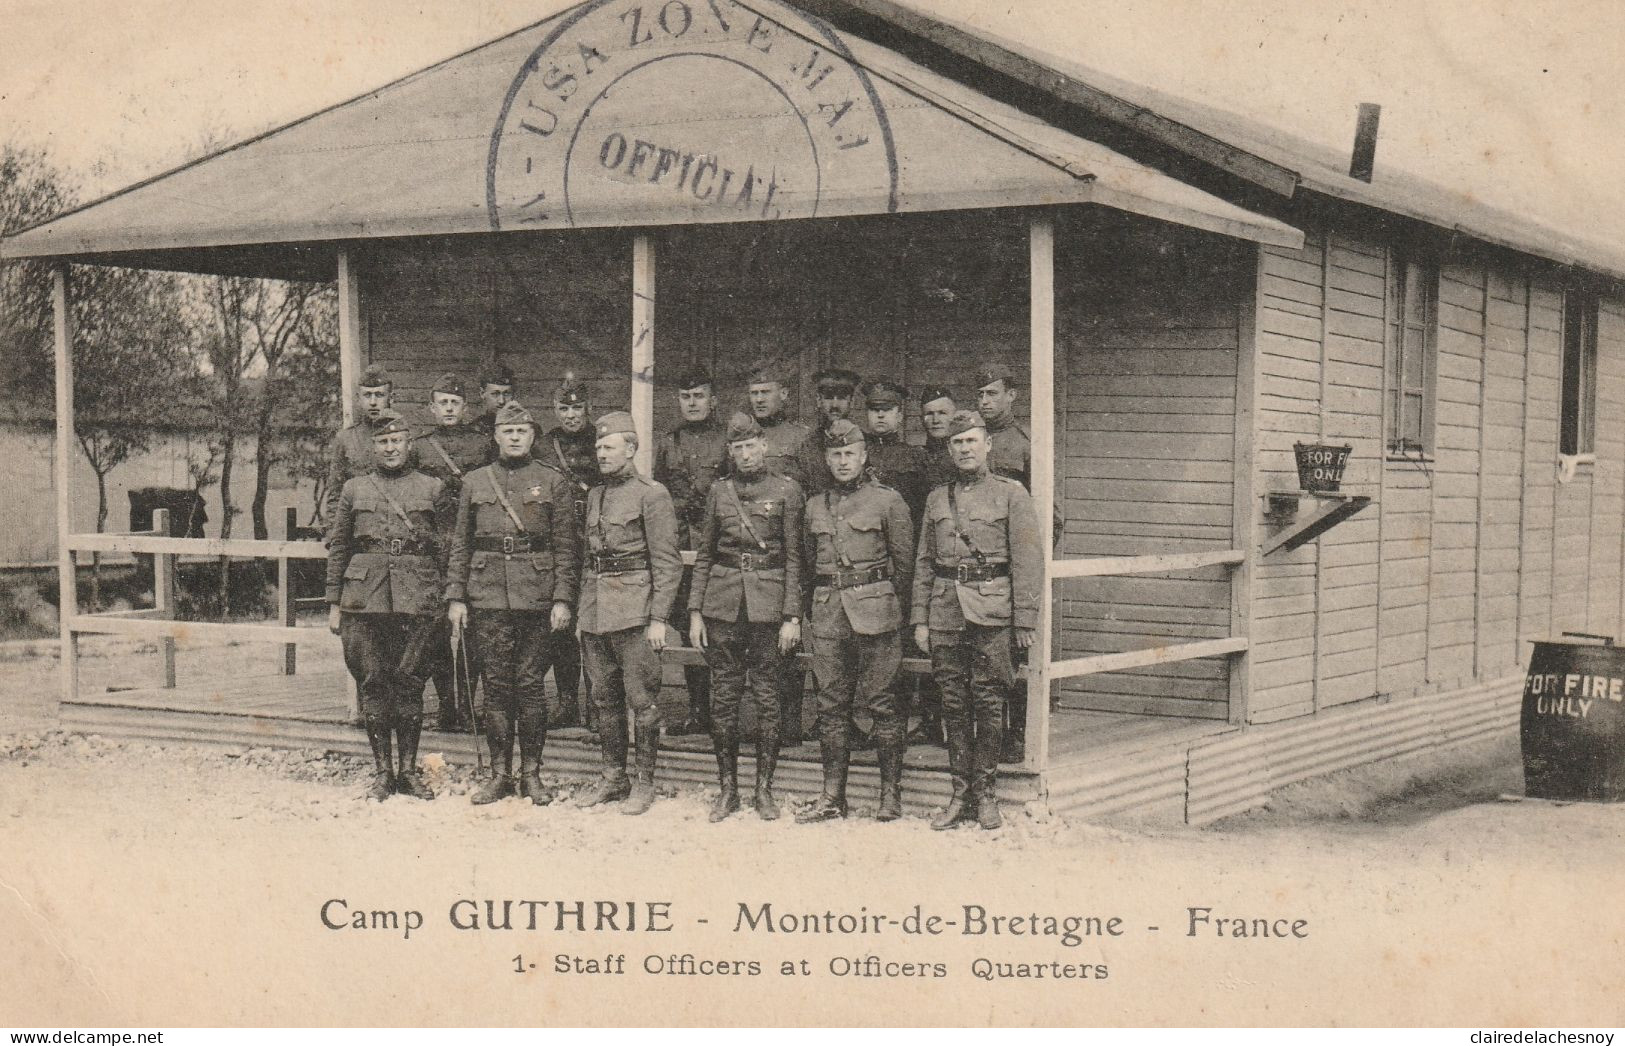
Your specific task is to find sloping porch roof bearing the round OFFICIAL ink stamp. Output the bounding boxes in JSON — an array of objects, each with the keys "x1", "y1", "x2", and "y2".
[{"x1": 0, "y1": 0, "x2": 1302, "y2": 278}]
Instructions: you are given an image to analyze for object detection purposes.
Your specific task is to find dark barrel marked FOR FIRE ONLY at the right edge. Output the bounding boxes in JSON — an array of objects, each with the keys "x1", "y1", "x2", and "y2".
[{"x1": 1519, "y1": 637, "x2": 1625, "y2": 802}]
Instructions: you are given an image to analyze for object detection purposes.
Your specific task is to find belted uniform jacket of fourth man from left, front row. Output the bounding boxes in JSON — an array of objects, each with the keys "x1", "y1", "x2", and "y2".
[{"x1": 689, "y1": 471, "x2": 803, "y2": 624}]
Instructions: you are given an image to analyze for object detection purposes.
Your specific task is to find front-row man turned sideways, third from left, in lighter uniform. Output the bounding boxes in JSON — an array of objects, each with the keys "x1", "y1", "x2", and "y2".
[{"x1": 575, "y1": 411, "x2": 683, "y2": 814}]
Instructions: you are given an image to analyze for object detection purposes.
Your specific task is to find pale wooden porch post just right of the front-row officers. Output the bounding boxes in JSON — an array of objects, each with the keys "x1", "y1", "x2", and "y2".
[{"x1": 1024, "y1": 218, "x2": 1056, "y2": 772}]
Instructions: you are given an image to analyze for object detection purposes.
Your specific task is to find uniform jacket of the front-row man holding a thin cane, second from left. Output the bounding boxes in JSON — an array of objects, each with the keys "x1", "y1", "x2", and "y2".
[{"x1": 445, "y1": 460, "x2": 582, "y2": 611}]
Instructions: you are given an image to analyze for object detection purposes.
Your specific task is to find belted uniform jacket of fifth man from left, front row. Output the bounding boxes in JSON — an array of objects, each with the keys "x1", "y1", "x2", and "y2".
[{"x1": 806, "y1": 481, "x2": 915, "y2": 635}]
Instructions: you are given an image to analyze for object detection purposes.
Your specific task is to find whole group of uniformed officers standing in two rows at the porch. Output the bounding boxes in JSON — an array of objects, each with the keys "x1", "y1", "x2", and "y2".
[{"x1": 327, "y1": 358, "x2": 1043, "y2": 828}]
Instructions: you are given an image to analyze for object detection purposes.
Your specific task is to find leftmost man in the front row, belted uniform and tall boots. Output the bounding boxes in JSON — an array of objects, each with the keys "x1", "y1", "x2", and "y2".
[{"x1": 327, "y1": 409, "x2": 450, "y2": 801}]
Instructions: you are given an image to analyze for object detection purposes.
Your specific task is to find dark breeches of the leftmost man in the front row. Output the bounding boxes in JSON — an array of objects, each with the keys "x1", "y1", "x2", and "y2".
[{"x1": 338, "y1": 612, "x2": 436, "y2": 726}]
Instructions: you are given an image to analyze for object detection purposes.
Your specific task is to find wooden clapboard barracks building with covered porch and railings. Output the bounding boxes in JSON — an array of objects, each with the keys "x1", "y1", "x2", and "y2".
[{"x1": 0, "y1": 0, "x2": 1625, "y2": 823}]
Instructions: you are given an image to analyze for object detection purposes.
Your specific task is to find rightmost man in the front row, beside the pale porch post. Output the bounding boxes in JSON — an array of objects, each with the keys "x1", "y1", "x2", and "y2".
[{"x1": 910, "y1": 411, "x2": 1043, "y2": 828}]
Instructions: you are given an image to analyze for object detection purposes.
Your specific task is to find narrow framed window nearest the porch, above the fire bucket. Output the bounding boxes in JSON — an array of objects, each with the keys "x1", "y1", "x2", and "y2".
[{"x1": 1386, "y1": 255, "x2": 1438, "y2": 456}]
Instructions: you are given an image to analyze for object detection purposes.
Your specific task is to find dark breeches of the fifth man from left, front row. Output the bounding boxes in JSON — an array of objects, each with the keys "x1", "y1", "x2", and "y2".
[{"x1": 813, "y1": 609, "x2": 904, "y2": 746}]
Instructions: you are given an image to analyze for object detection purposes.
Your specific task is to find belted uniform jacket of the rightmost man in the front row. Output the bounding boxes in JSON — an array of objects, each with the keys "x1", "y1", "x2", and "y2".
[{"x1": 910, "y1": 473, "x2": 1043, "y2": 632}]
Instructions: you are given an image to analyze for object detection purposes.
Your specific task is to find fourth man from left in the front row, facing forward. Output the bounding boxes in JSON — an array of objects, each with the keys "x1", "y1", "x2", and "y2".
[{"x1": 689, "y1": 414, "x2": 803, "y2": 822}]
